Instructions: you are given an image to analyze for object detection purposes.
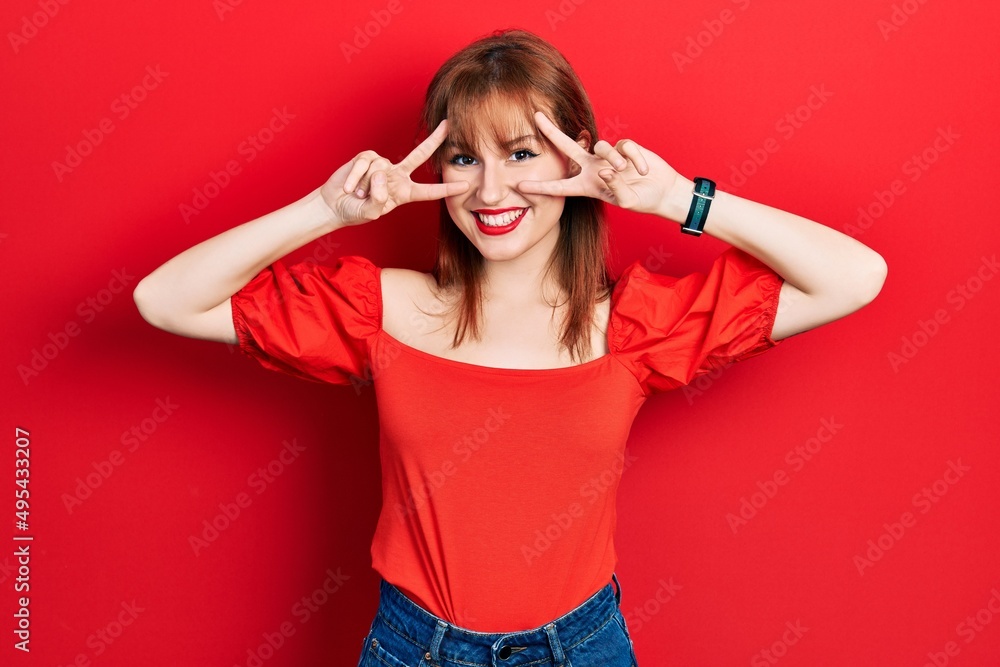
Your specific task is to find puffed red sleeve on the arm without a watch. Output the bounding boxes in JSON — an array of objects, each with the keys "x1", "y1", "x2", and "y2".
[{"x1": 231, "y1": 255, "x2": 381, "y2": 384}]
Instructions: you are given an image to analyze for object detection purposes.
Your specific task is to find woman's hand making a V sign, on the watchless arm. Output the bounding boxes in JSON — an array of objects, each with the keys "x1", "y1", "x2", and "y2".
[{"x1": 320, "y1": 119, "x2": 469, "y2": 225}]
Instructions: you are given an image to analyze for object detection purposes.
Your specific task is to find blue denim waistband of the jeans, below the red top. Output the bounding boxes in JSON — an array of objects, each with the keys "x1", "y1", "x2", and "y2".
[{"x1": 378, "y1": 574, "x2": 621, "y2": 667}]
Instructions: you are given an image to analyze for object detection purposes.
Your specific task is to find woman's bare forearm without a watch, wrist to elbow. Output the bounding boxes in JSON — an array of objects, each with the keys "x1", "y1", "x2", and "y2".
[{"x1": 134, "y1": 188, "x2": 343, "y2": 322}]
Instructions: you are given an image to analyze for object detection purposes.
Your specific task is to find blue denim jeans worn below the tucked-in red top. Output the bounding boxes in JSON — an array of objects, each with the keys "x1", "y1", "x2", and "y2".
[{"x1": 358, "y1": 574, "x2": 636, "y2": 667}]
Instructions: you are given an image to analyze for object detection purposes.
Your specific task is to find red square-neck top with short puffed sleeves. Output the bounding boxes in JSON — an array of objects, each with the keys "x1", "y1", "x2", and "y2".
[{"x1": 232, "y1": 248, "x2": 782, "y2": 632}]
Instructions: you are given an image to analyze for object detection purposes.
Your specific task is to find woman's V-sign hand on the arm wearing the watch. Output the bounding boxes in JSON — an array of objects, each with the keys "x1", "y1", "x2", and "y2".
[{"x1": 517, "y1": 111, "x2": 682, "y2": 213}]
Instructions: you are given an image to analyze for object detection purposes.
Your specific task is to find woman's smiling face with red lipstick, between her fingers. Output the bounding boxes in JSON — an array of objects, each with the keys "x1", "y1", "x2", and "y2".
[{"x1": 441, "y1": 113, "x2": 587, "y2": 261}]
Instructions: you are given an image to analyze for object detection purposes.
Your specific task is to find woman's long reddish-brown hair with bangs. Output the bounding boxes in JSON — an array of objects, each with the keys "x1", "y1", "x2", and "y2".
[{"x1": 421, "y1": 29, "x2": 614, "y2": 360}]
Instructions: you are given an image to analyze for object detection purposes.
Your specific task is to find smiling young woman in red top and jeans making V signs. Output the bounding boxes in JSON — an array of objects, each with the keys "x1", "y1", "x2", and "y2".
[{"x1": 135, "y1": 30, "x2": 886, "y2": 667}]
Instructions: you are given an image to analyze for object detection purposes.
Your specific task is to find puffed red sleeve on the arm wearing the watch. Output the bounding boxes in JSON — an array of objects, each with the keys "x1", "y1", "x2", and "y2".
[{"x1": 609, "y1": 247, "x2": 783, "y2": 395}]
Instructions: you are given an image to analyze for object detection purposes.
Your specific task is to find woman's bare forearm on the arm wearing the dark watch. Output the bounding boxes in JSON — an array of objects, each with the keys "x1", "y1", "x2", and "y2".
[{"x1": 660, "y1": 176, "x2": 885, "y2": 302}]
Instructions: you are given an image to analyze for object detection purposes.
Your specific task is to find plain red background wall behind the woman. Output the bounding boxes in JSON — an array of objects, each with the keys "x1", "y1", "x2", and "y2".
[{"x1": 0, "y1": 0, "x2": 1000, "y2": 667}]
